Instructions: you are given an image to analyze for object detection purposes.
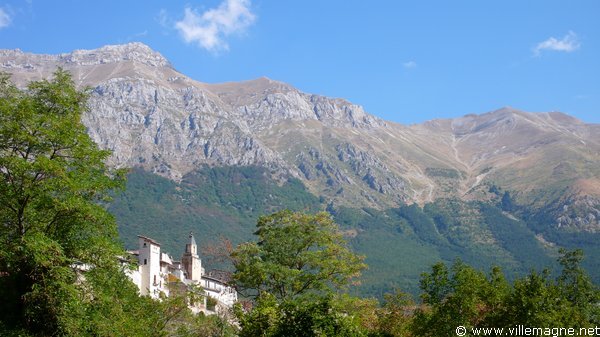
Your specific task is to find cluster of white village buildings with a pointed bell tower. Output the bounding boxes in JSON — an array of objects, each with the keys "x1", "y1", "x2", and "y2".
[{"x1": 128, "y1": 233, "x2": 237, "y2": 314}]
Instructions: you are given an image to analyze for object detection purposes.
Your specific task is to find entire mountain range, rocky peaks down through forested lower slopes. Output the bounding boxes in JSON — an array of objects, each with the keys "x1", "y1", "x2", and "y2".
[{"x1": 0, "y1": 43, "x2": 600, "y2": 297}]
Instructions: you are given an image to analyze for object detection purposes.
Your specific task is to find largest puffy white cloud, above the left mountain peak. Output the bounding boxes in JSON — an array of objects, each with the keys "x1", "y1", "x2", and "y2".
[{"x1": 175, "y1": 0, "x2": 256, "y2": 52}]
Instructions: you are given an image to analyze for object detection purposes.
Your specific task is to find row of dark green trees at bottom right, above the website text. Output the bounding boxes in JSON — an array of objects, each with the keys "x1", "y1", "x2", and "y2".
[{"x1": 412, "y1": 250, "x2": 600, "y2": 336}]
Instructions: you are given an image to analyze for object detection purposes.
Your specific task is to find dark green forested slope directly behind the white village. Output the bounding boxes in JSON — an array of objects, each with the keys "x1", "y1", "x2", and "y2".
[{"x1": 109, "y1": 166, "x2": 319, "y2": 256}]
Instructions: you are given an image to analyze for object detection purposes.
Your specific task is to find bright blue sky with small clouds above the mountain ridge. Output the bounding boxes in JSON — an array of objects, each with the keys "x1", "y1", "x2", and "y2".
[{"x1": 0, "y1": 0, "x2": 600, "y2": 124}]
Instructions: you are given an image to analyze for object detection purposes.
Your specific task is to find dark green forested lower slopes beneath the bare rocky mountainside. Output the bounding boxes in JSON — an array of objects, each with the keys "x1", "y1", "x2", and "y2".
[{"x1": 110, "y1": 167, "x2": 600, "y2": 298}]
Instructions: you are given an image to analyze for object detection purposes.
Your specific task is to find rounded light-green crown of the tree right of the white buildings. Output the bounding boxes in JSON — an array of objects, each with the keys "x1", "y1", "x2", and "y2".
[{"x1": 232, "y1": 210, "x2": 366, "y2": 300}]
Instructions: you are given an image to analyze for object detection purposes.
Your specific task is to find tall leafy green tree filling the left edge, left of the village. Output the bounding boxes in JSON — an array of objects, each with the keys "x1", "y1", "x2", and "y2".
[{"x1": 0, "y1": 70, "x2": 159, "y2": 336}]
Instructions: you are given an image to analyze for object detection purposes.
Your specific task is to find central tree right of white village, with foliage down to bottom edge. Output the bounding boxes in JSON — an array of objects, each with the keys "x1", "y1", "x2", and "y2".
[{"x1": 232, "y1": 210, "x2": 366, "y2": 336}]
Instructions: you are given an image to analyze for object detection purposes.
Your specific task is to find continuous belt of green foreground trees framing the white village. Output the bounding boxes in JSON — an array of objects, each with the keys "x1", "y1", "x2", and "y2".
[{"x1": 0, "y1": 70, "x2": 600, "y2": 337}]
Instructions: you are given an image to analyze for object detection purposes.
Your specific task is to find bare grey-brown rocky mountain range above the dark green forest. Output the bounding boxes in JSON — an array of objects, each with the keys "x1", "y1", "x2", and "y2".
[{"x1": 0, "y1": 43, "x2": 600, "y2": 296}]
